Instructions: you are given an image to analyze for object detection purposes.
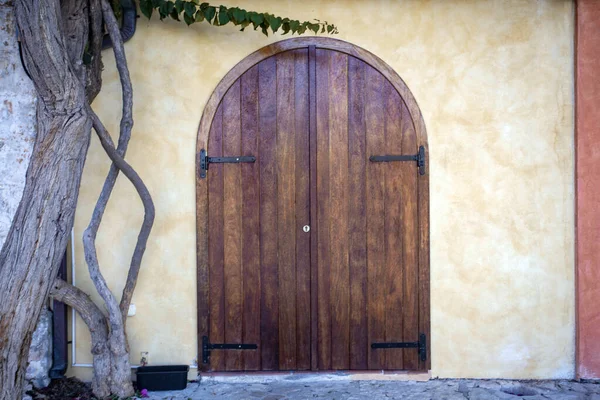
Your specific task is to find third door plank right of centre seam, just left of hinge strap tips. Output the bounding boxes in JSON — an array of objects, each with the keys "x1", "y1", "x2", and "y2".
[{"x1": 348, "y1": 57, "x2": 369, "y2": 369}]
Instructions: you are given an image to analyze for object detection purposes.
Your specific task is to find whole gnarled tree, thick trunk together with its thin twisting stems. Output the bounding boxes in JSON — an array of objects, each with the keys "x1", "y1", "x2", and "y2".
[{"x1": 0, "y1": 0, "x2": 154, "y2": 400}]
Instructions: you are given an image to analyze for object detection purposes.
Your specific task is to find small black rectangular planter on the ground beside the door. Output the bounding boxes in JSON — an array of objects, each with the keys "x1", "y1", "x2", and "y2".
[{"x1": 137, "y1": 365, "x2": 190, "y2": 390}]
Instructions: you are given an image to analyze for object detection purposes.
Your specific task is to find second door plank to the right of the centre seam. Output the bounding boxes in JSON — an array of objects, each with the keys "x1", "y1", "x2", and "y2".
[{"x1": 329, "y1": 52, "x2": 350, "y2": 369}]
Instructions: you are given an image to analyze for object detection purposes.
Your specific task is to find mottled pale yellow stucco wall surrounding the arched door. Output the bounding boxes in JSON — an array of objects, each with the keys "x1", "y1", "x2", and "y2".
[{"x1": 70, "y1": 0, "x2": 574, "y2": 378}]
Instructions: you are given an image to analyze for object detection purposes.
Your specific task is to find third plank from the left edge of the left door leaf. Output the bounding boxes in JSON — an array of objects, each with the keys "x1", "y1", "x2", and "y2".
[{"x1": 240, "y1": 66, "x2": 260, "y2": 371}]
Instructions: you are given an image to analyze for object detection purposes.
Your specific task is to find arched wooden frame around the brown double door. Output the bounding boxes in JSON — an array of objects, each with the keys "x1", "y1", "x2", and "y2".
[{"x1": 196, "y1": 37, "x2": 431, "y2": 371}]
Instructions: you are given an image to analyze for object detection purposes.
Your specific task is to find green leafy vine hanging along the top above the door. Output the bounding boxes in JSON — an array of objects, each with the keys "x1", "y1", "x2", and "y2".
[{"x1": 140, "y1": 0, "x2": 338, "y2": 36}]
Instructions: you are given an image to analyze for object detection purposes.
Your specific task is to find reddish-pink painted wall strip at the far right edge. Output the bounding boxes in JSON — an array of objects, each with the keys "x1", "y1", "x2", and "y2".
[{"x1": 575, "y1": 0, "x2": 600, "y2": 379}]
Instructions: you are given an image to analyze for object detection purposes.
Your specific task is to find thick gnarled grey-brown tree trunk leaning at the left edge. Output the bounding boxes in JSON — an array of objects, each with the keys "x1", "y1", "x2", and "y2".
[{"x1": 0, "y1": 0, "x2": 92, "y2": 400}]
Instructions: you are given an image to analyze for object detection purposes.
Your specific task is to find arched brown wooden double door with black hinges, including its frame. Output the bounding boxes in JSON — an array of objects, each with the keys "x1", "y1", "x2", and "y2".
[{"x1": 197, "y1": 38, "x2": 430, "y2": 371}]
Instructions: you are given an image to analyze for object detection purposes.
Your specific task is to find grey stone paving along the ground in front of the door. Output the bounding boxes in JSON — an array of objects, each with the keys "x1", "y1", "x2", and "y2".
[{"x1": 144, "y1": 376, "x2": 600, "y2": 400}]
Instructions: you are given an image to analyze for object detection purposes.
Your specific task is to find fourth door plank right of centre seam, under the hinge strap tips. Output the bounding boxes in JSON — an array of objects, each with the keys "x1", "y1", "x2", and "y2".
[{"x1": 365, "y1": 67, "x2": 387, "y2": 369}]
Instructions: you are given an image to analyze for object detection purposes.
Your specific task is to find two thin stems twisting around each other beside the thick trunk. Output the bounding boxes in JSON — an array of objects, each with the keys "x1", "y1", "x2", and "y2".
[{"x1": 75, "y1": 0, "x2": 155, "y2": 397}]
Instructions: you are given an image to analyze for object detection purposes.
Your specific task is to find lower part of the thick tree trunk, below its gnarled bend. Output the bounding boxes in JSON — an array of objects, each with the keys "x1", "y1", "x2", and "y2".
[{"x1": 0, "y1": 105, "x2": 91, "y2": 400}]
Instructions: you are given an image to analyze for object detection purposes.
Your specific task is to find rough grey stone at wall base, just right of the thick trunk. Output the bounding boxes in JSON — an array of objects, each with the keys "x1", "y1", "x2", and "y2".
[{"x1": 25, "y1": 310, "x2": 52, "y2": 389}]
